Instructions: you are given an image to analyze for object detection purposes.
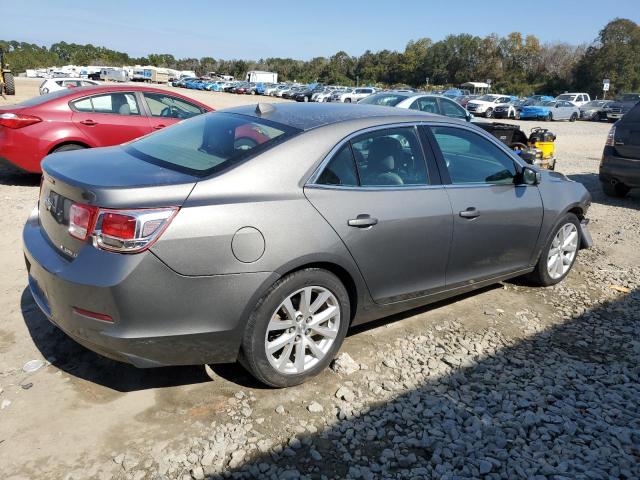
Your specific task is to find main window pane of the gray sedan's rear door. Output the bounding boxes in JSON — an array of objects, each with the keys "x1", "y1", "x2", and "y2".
[{"x1": 351, "y1": 127, "x2": 429, "y2": 187}]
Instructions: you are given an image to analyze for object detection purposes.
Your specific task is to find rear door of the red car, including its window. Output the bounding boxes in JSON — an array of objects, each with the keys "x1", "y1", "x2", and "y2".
[{"x1": 71, "y1": 92, "x2": 151, "y2": 147}]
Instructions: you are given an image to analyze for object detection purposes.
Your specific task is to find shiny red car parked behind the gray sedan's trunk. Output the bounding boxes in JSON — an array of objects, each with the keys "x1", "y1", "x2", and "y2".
[{"x1": 0, "y1": 85, "x2": 212, "y2": 173}]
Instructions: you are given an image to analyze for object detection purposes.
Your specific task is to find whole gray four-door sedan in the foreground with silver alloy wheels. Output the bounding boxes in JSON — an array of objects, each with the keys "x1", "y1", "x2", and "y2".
[{"x1": 23, "y1": 104, "x2": 591, "y2": 387}]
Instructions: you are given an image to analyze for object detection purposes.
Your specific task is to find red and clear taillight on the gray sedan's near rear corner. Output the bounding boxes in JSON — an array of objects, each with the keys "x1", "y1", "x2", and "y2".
[{"x1": 69, "y1": 204, "x2": 178, "y2": 253}]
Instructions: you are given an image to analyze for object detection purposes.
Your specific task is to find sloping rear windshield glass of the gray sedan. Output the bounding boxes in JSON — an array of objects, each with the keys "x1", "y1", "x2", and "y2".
[{"x1": 126, "y1": 112, "x2": 300, "y2": 176}]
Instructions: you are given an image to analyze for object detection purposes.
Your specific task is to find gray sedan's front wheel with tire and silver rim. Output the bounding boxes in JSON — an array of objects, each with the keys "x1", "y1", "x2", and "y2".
[{"x1": 528, "y1": 213, "x2": 581, "y2": 287}]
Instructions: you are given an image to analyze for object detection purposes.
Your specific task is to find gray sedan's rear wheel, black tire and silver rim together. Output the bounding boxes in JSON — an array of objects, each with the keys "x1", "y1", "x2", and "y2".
[{"x1": 240, "y1": 268, "x2": 351, "y2": 388}]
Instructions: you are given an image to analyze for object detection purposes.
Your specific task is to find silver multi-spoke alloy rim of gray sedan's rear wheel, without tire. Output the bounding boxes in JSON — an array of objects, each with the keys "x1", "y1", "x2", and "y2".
[{"x1": 264, "y1": 286, "x2": 340, "y2": 374}]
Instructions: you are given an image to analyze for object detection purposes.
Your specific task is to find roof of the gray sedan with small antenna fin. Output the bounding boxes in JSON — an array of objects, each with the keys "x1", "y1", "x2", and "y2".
[{"x1": 222, "y1": 103, "x2": 457, "y2": 131}]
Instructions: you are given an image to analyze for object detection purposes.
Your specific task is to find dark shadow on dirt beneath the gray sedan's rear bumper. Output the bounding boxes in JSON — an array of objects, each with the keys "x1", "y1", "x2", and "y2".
[{"x1": 20, "y1": 288, "x2": 210, "y2": 392}]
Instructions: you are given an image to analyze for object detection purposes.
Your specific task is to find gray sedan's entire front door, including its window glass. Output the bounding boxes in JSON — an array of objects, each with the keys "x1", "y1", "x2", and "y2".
[{"x1": 428, "y1": 126, "x2": 543, "y2": 286}]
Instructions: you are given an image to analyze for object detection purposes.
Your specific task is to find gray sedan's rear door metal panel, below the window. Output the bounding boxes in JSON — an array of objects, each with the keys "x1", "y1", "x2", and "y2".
[{"x1": 305, "y1": 186, "x2": 452, "y2": 303}]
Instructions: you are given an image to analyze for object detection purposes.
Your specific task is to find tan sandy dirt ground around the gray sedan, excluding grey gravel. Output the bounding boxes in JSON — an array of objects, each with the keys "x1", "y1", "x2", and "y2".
[{"x1": 0, "y1": 79, "x2": 640, "y2": 479}]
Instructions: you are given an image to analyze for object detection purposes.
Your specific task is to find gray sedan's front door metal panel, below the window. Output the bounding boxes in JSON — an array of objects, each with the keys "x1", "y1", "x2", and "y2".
[{"x1": 446, "y1": 185, "x2": 542, "y2": 286}]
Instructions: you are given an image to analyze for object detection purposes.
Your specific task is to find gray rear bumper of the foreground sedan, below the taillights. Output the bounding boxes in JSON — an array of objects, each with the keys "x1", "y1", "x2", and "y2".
[{"x1": 23, "y1": 208, "x2": 278, "y2": 367}]
